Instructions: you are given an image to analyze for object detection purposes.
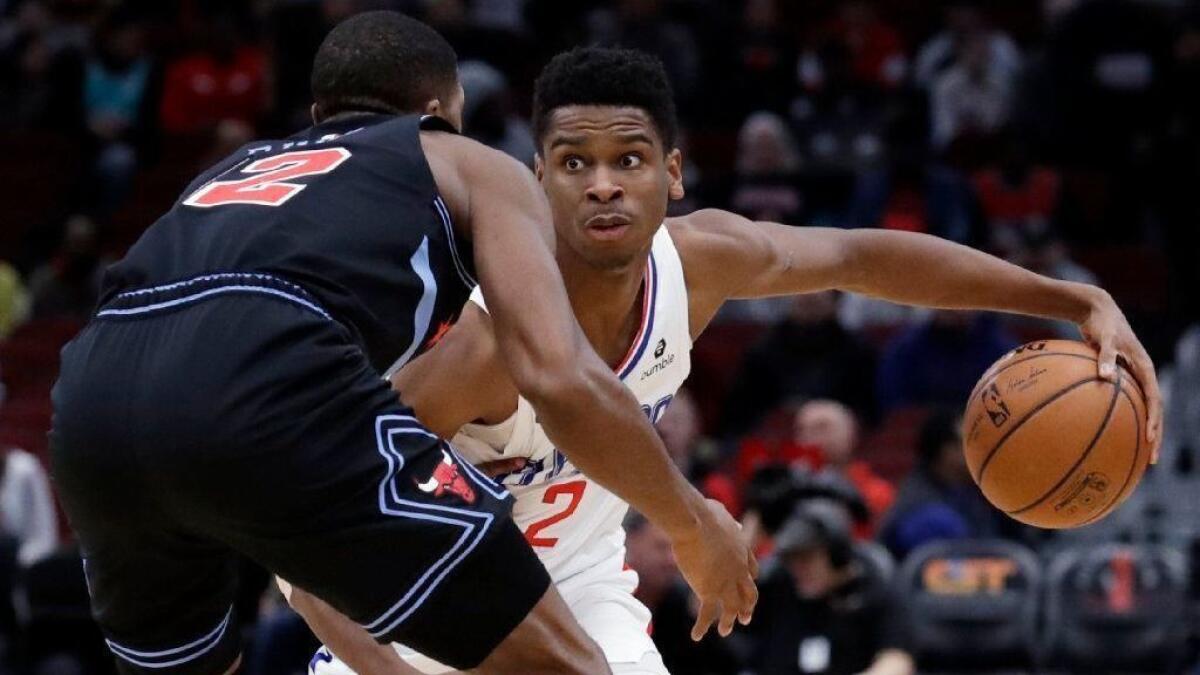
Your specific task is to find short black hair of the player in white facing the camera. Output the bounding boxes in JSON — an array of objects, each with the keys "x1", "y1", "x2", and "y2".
[{"x1": 533, "y1": 47, "x2": 679, "y2": 150}]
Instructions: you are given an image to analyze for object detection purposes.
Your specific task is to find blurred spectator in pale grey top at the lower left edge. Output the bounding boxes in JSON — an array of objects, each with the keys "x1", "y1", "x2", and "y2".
[{"x1": 0, "y1": 448, "x2": 59, "y2": 567}]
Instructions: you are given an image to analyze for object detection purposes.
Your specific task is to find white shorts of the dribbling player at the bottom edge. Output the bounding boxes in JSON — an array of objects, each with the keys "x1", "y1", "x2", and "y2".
[{"x1": 308, "y1": 551, "x2": 668, "y2": 675}]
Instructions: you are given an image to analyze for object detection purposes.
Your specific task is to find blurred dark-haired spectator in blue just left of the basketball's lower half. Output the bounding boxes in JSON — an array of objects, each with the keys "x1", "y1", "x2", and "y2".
[{"x1": 880, "y1": 408, "x2": 1013, "y2": 560}]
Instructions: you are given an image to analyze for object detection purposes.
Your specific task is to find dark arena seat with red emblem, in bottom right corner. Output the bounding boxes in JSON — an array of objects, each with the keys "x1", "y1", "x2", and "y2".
[{"x1": 1044, "y1": 544, "x2": 1188, "y2": 673}]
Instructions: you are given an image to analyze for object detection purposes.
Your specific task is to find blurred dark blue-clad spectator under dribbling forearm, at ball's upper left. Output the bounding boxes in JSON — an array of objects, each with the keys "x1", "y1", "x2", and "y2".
[{"x1": 877, "y1": 310, "x2": 1018, "y2": 413}]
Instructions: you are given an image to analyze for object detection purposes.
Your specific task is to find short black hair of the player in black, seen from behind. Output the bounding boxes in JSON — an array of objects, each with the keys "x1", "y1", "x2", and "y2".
[{"x1": 312, "y1": 11, "x2": 458, "y2": 118}]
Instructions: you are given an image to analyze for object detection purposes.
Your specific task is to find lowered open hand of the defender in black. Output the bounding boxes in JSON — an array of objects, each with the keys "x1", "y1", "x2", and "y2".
[{"x1": 671, "y1": 500, "x2": 758, "y2": 641}]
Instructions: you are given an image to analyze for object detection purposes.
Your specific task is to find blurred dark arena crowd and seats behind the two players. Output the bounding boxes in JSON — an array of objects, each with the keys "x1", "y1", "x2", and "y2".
[{"x1": 0, "y1": 0, "x2": 1200, "y2": 675}]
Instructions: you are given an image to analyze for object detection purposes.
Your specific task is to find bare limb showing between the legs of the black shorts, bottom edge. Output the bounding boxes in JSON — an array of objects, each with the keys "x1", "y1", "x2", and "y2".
[{"x1": 287, "y1": 581, "x2": 420, "y2": 675}]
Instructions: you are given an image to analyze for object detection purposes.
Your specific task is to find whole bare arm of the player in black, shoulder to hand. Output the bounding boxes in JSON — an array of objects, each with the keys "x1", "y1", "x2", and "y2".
[{"x1": 422, "y1": 135, "x2": 757, "y2": 637}]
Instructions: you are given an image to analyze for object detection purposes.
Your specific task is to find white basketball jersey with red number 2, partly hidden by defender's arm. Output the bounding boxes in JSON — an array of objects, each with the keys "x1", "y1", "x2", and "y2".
[{"x1": 454, "y1": 227, "x2": 691, "y2": 581}]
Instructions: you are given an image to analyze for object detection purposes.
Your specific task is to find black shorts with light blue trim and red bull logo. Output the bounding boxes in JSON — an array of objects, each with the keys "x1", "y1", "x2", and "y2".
[{"x1": 50, "y1": 275, "x2": 550, "y2": 674}]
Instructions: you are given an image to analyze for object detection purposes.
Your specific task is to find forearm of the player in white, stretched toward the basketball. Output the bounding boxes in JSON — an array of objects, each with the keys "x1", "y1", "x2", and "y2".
[{"x1": 839, "y1": 229, "x2": 1104, "y2": 323}]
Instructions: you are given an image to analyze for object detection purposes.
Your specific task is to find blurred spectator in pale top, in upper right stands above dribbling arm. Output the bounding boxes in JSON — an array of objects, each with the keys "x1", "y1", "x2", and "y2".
[{"x1": 930, "y1": 34, "x2": 1013, "y2": 150}]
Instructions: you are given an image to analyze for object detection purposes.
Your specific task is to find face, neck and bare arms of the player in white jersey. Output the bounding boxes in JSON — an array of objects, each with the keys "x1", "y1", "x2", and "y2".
[{"x1": 285, "y1": 106, "x2": 1162, "y2": 661}]
